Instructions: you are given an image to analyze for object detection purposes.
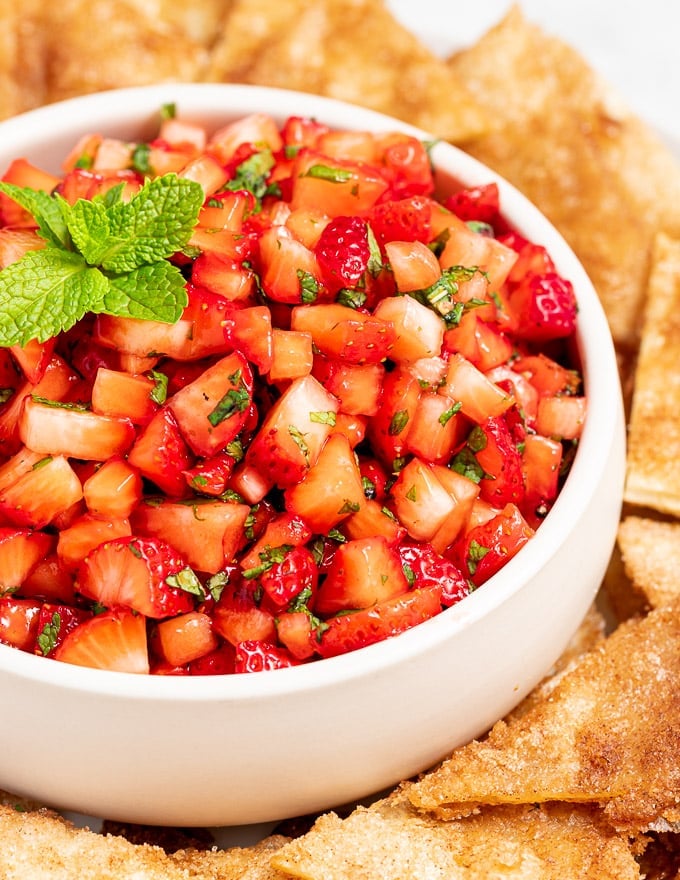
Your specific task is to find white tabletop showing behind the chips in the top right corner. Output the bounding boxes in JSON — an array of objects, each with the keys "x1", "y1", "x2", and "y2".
[{"x1": 387, "y1": 0, "x2": 680, "y2": 142}]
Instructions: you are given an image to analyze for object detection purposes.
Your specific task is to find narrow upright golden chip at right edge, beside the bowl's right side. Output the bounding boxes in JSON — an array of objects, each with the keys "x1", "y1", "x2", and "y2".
[{"x1": 624, "y1": 234, "x2": 680, "y2": 516}]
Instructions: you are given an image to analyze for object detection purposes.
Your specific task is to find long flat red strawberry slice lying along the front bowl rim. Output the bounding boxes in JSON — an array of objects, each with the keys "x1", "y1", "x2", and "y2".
[{"x1": 319, "y1": 589, "x2": 442, "y2": 657}]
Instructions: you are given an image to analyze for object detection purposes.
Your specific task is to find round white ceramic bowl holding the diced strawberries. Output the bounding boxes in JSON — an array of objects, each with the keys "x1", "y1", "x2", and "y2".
[{"x1": 0, "y1": 84, "x2": 625, "y2": 826}]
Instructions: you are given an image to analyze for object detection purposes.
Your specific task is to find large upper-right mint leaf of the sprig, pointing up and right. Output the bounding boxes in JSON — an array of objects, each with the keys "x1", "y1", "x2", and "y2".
[{"x1": 101, "y1": 174, "x2": 204, "y2": 273}]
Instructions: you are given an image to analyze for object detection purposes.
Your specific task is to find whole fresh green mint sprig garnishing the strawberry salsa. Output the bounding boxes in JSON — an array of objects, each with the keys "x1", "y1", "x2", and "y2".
[{"x1": 0, "y1": 174, "x2": 204, "y2": 346}]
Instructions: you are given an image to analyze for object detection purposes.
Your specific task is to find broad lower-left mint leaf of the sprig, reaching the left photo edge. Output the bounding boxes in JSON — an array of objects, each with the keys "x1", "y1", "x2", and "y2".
[{"x1": 0, "y1": 246, "x2": 108, "y2": 346}]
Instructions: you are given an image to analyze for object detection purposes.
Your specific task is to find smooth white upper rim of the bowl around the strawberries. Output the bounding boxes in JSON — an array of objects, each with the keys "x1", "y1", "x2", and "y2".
[{"x1": 0, "y1": 83, "x2": 622, "y2": 703}]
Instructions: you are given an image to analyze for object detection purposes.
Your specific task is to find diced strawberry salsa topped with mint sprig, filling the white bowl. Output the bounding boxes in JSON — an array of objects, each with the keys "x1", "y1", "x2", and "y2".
[{"x1": 0, "y1": 107, "x2": 586, "y2": 675}]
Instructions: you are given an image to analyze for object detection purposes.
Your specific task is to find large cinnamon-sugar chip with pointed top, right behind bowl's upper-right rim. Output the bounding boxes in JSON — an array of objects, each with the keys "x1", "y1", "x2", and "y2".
[{"x1": 450, "y1": 8, "x2": 680, "y2": 348}]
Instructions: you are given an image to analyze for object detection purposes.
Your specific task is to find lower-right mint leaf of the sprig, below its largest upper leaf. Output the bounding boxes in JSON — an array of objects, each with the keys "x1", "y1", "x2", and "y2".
[{"x1": 106, "y1": 261, "x2": 188, "y2": 324}]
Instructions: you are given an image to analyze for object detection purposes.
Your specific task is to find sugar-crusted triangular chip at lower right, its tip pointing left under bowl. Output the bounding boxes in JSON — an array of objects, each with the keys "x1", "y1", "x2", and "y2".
[{"x1": 407, "y1": 603, "x2": 680, "y2": 833}]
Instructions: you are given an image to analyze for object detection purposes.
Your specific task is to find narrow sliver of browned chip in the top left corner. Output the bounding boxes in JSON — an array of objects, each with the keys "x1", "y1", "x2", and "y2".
[{"x1": 0, "y1": 0, "x2": 46, "y2": 119}]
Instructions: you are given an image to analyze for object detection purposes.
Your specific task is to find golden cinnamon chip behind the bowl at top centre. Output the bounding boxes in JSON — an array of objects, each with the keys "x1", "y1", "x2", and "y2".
[{"x1": 208, "y1": 0, "x2": 486, "y2": 141}]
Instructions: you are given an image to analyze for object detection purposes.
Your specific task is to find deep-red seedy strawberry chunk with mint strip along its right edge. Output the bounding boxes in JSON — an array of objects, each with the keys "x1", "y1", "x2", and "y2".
[{"x1": 314, "y1": 217, "x2": 371, "y2": 293}]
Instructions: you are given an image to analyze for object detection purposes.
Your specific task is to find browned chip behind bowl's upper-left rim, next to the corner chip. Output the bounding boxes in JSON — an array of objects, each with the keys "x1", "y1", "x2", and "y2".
[{"x1": 42, "y1": 0, "x2": 209, "y2": 101}]
